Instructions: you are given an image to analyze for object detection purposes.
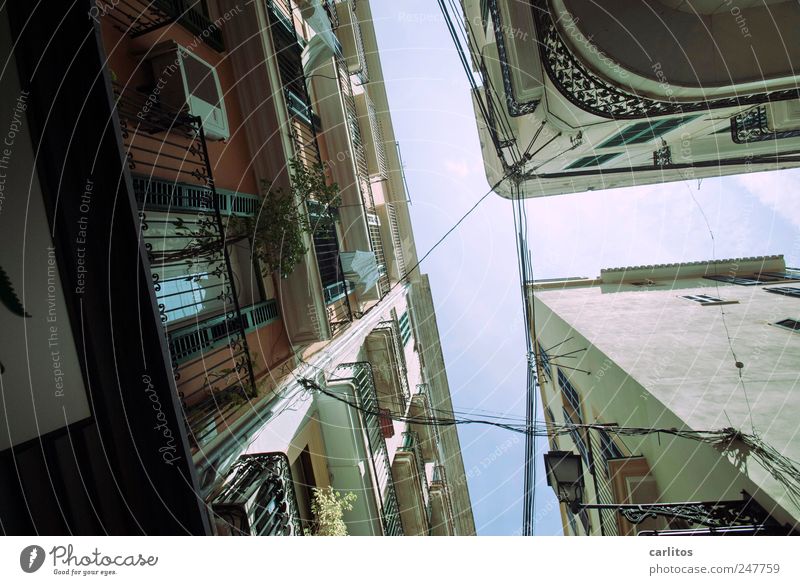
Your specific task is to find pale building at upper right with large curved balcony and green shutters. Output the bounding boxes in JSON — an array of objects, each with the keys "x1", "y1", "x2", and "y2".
[{"x1": 456, "y1": 0, "x2": 800, "y2": 197}]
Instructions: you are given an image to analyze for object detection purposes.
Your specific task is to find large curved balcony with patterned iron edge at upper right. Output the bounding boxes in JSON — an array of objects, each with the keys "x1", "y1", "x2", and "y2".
[{"x1": 524, "y1": 0, "x2": 798, "y2": 120}]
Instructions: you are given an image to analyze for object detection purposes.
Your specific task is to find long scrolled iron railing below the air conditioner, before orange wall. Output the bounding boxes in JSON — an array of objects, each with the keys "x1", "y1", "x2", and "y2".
[{"x1": 115, "y1": 87, "x2": 258, "y2": 444}]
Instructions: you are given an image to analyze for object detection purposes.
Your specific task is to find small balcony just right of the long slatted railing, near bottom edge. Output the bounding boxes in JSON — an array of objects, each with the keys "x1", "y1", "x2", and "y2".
[{"x1": 392, "y1": 431, "x2": 431, "y2": 536}]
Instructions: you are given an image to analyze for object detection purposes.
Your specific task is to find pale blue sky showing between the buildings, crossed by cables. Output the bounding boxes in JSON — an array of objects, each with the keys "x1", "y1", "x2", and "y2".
[{"x1": 372, "y1": 0, "x2": 800, "y2": 535}]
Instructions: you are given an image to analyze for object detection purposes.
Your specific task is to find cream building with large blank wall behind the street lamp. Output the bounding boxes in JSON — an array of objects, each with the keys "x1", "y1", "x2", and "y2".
[{"x1": 528, "y1": 256, "x2": 800, "y2": 535}]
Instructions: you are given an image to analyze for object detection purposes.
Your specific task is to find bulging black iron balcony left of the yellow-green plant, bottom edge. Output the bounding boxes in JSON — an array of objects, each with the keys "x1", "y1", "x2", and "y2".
[{"x1": 211, "y1": 453, "x2": 303, "y2": 536}]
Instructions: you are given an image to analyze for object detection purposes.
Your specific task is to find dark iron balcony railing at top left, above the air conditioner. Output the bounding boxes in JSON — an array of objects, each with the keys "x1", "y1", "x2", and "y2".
[{"x1": 105, "y1": 0, "x2": 225, "y2": 51}]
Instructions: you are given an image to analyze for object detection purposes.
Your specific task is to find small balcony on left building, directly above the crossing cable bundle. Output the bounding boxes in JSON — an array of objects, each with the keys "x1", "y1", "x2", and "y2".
[{"x1": 366, "y1": 321, "x2": 411, "y2": 416}]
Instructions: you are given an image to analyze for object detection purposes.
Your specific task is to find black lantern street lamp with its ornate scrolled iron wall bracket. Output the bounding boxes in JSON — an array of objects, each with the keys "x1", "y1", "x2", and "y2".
[{"x1": 544, "y1": 451, "x2": 794, "y2": 534}]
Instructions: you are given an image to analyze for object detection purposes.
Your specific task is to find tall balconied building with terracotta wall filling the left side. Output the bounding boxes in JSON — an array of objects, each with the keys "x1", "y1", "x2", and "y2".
[{"x1": 2, "y1": 0, "x2": 475, "y2": 535}]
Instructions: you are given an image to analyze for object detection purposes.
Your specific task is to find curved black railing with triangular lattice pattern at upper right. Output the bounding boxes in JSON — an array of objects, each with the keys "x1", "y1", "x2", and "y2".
[{"x1": 528, "y1": 0, "x2": 800, "y2": 120}]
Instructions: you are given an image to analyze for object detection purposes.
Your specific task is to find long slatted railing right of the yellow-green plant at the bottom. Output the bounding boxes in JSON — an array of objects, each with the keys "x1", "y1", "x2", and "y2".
[{"x1": 336, "y1": 362, "x2": 403, "y2": 536}]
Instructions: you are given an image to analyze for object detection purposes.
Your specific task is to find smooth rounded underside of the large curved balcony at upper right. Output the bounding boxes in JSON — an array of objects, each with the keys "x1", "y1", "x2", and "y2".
[{"x1": 552, "y1": 0, "x2": 800, "y2": 87}]
